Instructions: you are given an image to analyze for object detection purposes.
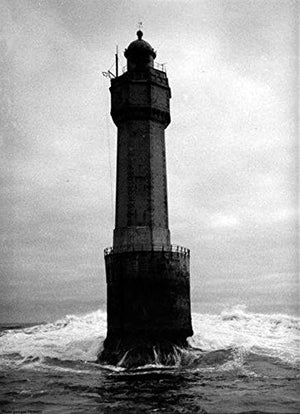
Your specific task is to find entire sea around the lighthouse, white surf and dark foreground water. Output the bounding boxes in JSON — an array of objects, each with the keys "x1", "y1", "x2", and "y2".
[{"x1": 0, "y1": 306, "x2": 300, "y2": 414}]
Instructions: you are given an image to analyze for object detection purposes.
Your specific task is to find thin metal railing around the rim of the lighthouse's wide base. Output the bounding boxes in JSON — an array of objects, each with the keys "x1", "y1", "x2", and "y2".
[{"x1": 104, "y1": 244, "x2": 190, "y2": 257}]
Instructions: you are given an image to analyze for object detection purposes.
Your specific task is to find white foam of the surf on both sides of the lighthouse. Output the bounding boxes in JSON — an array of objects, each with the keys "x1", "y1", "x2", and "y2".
[{"x1": 0, "y1": 306, "x2": 300, "y2": 364}]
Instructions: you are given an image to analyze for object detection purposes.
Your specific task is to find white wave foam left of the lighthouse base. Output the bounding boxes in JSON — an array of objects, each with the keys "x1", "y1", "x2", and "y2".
[{"x1": 0, "y1": 310, "x2": 106, "y2": 362}]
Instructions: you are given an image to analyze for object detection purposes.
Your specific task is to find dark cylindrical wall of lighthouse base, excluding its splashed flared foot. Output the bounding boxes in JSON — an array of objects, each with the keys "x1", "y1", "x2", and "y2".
[{"x1": 105, "y1": 251, "x2": 192, "y2": 339}]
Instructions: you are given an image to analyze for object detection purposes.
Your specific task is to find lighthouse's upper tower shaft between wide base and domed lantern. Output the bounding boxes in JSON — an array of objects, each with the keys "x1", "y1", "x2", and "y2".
[{"x1": 111, "y1": 67, "x2": 171, "y2": 250}]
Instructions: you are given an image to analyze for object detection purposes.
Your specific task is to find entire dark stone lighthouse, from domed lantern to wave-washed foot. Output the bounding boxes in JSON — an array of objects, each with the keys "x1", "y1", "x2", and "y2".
[{"x1": 99, "y1": 31, "x2": 193, "y2": 366}]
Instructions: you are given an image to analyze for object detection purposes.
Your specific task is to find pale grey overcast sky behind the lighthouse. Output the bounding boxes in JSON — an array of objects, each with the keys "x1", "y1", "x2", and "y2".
[{"x1": 0, "y1": 0, "x2": 298, "y2": 322}]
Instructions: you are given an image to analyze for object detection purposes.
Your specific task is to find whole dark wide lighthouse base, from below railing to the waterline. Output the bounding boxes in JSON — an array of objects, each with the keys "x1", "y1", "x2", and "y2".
[{"x1": 99, "y1": 251, "x2": 193, "y2": 367}]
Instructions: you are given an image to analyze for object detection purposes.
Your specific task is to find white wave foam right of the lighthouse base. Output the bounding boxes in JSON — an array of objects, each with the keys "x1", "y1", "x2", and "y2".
[{"x1": 192, "y1": 305, "x2": 300, "y2": 362}]
